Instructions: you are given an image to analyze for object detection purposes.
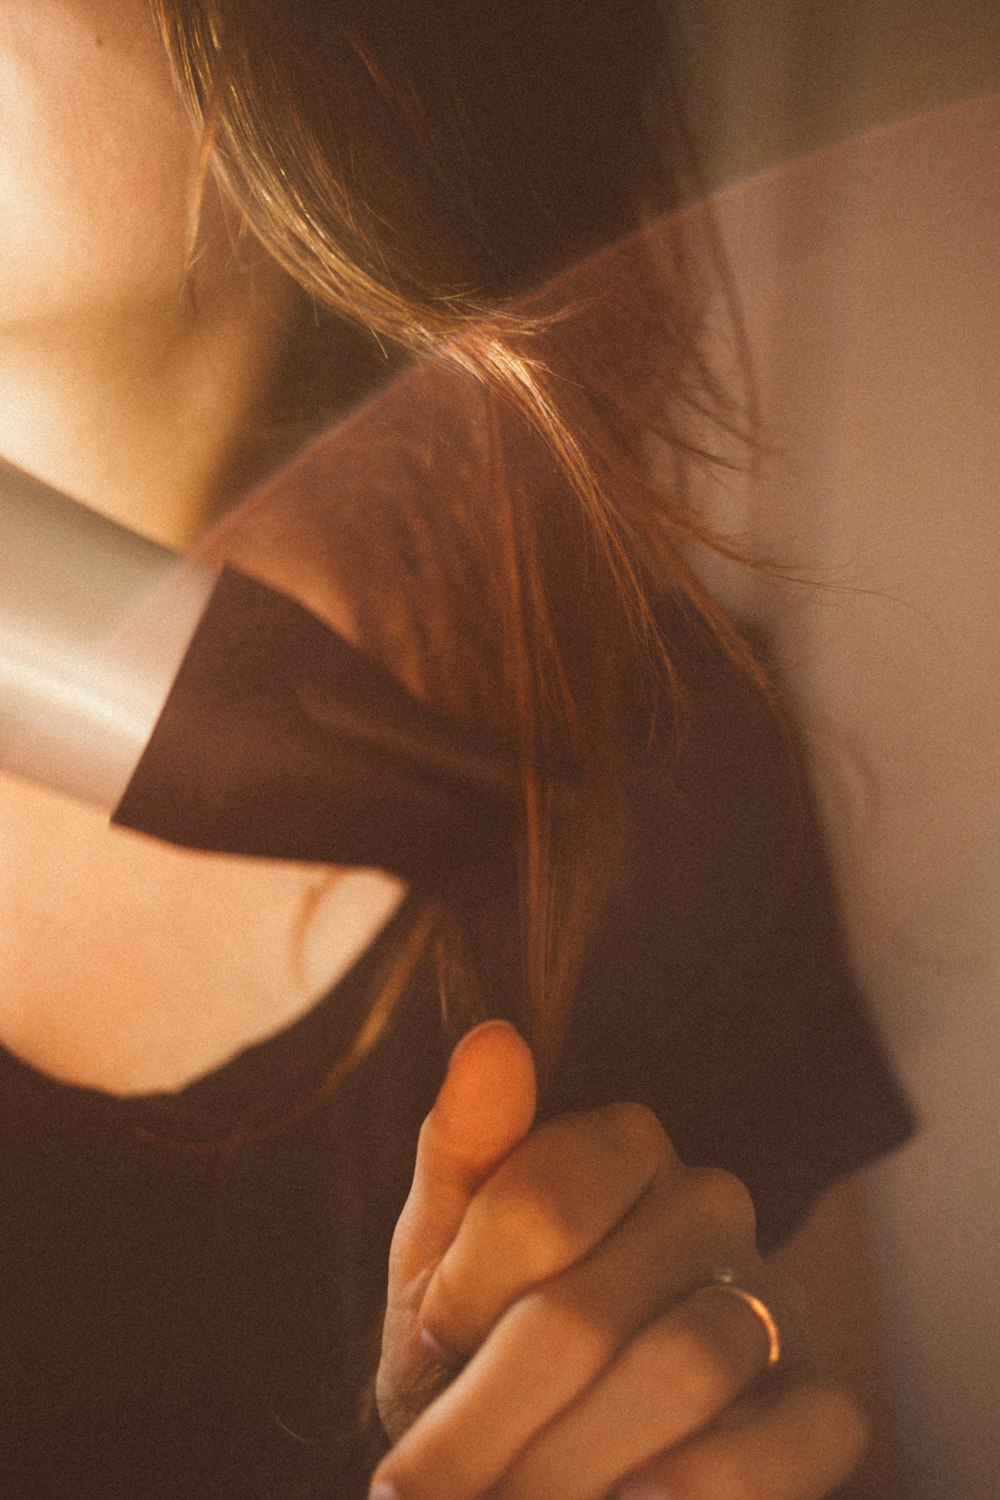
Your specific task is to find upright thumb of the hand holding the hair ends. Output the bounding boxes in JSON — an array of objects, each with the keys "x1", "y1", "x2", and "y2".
[{"x1": 388, "y1": 1022, "x2": 537, "y2": 1304}]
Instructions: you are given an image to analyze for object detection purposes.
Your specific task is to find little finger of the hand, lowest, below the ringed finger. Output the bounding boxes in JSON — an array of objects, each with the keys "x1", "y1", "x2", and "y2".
[{"x1": 617, "y1": 1380, "x2": 867, "y2": 1500}]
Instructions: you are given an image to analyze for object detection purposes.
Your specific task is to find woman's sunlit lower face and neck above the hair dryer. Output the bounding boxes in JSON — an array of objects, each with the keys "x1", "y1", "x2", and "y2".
[{"x1": 0, "y1": 0, "x2": 299, "y2": 545}]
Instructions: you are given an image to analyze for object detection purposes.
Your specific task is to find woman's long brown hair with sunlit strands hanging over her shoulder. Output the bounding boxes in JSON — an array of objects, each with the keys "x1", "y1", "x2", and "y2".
[{"x1": 151, "y1": 0, "x2": 815, "y2": 1098}]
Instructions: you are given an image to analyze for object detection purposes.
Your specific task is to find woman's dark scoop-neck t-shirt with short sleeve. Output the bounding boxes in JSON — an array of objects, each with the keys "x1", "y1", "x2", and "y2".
[{"x1": 0, "y1": 591, "x2": 910, "y2": 1500}]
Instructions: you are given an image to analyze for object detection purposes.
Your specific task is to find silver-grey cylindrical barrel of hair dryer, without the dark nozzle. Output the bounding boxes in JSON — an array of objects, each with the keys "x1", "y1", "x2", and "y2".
[{"x1": 0, "y1": 461, "x2": 216, "y2": 809}]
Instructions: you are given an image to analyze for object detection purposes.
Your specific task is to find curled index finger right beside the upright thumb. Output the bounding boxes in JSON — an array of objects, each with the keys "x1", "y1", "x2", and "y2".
[{"x1": 420, "y1": 1104, "x2": 682, "y2": 1356}]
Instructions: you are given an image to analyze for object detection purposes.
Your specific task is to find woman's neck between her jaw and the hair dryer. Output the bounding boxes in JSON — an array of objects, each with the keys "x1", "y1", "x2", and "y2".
[{"x1": 0, "y1": 242, "x2": 297, "y2": 548}]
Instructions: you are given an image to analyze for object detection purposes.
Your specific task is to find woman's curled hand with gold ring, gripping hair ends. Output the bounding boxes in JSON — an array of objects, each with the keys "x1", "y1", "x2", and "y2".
[{"x1": 372, "y1": 1022, "x2": 864, "y2": 1500}]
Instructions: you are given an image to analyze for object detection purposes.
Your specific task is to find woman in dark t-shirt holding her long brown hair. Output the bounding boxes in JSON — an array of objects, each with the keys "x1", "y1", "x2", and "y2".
[{"x1": 0, "y1": 0, "x2": 907, "y2": 1500}]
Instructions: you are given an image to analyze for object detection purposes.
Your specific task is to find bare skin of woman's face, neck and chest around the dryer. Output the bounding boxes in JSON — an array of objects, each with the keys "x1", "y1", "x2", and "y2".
[{"x1": 0, "y1": 0, "x2": 389, "y2": 1094}]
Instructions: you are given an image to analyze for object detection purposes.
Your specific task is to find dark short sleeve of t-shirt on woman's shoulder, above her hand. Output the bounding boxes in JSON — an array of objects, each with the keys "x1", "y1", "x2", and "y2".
[{"x1": 546, "y1": 597, "x2": 913, "y2": 1251}]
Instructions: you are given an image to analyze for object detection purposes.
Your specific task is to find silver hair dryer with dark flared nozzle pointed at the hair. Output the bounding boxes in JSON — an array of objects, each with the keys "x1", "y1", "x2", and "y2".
[{"x1": 0, "y1": 464, "x2": 527, "y2": 896}]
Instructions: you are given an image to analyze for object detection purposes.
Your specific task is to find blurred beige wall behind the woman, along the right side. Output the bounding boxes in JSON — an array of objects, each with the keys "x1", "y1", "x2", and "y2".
[{"x1": 665, "y1": 11, "x2": 1000, "y2": 1500}]
